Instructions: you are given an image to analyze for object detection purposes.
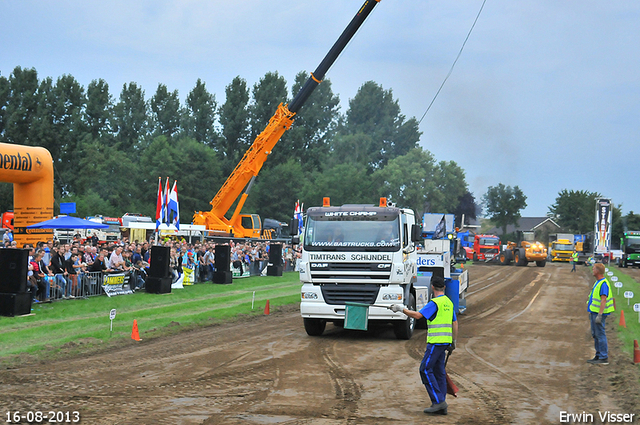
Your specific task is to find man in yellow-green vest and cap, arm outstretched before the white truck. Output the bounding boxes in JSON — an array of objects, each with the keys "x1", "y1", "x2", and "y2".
[{"x1": 389, "y1": 276, "x2": 458, "y2": 415}]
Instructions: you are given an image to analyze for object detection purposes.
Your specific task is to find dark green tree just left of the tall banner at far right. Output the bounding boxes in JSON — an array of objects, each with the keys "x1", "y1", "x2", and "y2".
[{"x1": 549, "y1": 189, "x2": 601, "y2": 234}]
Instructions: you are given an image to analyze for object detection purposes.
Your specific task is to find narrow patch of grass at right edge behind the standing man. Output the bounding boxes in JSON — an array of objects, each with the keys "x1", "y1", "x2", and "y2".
[{"x1": 605, "y1": 267, "x2": 640, "y2": 358}]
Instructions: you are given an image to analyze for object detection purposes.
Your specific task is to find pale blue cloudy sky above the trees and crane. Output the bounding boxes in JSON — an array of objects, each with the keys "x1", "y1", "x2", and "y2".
[{"x1": 0, "y1": 0, "x2": 640, "y2": 217}]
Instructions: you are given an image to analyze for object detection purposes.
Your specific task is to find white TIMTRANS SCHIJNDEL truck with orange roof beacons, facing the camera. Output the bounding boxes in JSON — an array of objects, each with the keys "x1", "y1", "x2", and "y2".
[{"x1": 293, "y1": 198, "x2": 428, "y2": 339}]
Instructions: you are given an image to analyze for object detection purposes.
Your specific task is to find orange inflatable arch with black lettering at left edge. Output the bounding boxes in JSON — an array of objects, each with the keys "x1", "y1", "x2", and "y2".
[{"x1": 0, "y1": 143, "x2": 53, "y2": 248}]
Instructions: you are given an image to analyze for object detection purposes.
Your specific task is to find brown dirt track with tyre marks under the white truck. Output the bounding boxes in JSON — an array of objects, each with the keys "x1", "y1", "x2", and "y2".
[{"x1": 0, "y1": 264, "x2": 640, "y2": 425}]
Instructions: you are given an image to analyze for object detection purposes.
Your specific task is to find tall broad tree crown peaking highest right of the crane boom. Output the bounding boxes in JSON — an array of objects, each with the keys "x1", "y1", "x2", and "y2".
[{"x1": 342, "y1": 81, "x2": 421, "y2": 170}]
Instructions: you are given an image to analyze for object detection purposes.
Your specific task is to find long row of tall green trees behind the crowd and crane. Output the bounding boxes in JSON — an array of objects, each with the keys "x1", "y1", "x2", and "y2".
[{"x1": 0, "y1": 67, "x2": 476, "y2": 222}]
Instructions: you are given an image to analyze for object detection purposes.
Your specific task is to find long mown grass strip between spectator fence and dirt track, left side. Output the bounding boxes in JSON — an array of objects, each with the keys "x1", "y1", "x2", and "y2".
[{"x1": 0, "y1": 272, "x2": 300, "y2": 360}]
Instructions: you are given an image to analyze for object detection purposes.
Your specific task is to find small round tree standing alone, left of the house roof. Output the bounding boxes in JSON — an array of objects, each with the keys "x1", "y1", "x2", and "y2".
[{"x1": 483, "y1": 183, "x2": 527, "y2": 236}]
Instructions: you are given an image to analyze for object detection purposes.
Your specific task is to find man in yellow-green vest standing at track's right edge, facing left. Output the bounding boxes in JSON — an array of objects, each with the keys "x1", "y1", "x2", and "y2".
[{"x1": 587, "y1": 263, "x2": 614, "y2": 364}]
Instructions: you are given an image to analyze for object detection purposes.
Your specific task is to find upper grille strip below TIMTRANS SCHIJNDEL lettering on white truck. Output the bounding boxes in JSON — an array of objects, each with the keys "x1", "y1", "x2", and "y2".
[{"x1": 310, "y1": 263, "x2": 391, "y2": 283}]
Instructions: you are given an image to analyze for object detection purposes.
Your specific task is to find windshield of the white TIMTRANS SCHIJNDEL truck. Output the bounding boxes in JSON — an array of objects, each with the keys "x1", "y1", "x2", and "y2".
[{"x1": 304, "y1": 212, "x2": 400, "y2": 251}]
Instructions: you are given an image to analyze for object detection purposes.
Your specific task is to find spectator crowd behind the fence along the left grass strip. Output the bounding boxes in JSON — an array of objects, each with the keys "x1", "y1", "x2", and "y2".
[{"x1": 0, "y1": 233, "x2": 300, "y2": 302}]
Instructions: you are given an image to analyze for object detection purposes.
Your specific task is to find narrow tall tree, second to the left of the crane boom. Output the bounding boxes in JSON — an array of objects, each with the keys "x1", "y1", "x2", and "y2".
[{"x1": 218, "y1": 76, "x2": 252, "y2": 175}]
